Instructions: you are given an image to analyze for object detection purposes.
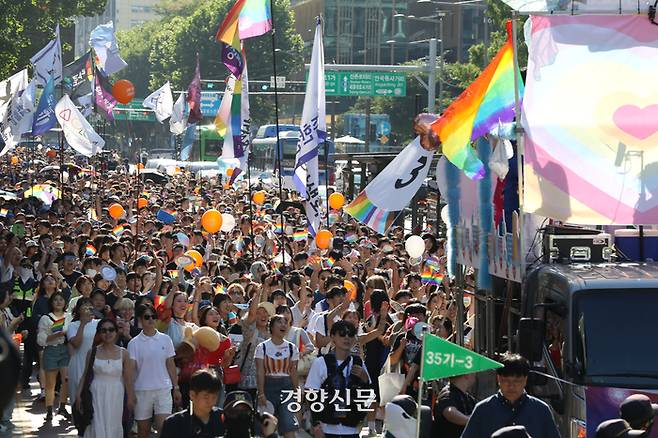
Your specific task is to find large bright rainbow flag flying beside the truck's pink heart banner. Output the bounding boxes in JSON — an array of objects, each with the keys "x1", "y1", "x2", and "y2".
[{"x1": 432, "y1": 23, "x2": 523, "y2": 180}]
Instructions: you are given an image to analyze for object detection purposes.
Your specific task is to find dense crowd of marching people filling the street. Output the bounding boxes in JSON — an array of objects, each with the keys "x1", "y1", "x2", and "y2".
[{"x1": 0, "y1": 148, "x2": 652, "y2": 438}]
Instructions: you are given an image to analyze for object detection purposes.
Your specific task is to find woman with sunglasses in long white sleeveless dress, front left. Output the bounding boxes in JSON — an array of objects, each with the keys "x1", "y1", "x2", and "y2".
[{"x1": 77, "y1": 318, "x2": 133, "y2": 438}]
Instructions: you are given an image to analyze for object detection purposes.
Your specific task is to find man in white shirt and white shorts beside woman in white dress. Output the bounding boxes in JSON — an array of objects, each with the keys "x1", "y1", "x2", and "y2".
[{"x1": 128, "y1": 304, "x2": 181, "y2": 438}]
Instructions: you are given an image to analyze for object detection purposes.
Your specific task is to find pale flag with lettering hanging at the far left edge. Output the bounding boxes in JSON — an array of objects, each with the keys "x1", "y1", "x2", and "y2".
[{"x1": 0, "y1": 78, "x2": 37, "y2": 156}]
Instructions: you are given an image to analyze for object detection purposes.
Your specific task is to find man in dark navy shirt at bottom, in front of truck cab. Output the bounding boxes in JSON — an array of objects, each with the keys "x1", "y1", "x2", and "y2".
[{"x1": 462, "y1": 352, "x2": 560, "y2": 438}]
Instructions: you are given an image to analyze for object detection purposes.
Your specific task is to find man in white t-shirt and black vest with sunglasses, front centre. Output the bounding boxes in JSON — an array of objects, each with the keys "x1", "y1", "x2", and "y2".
[{"x1": 305, "y1": 320, "x2": 374, "y2": 438}]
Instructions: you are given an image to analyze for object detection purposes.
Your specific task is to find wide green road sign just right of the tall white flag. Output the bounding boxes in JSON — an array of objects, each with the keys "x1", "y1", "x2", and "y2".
[{"x1": 324, "y1": 71, "x2": 407, "y2": 97}]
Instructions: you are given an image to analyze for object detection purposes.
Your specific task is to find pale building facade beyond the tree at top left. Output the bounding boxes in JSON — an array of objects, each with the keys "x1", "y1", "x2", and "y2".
[{"x1": 75, "y1": 0, "x2": 159, "y2": 58}]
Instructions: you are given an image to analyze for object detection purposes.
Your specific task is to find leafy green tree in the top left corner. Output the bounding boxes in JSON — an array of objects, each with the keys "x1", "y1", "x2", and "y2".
[{"x1": 0, "y1": 0, "x2": 107, "y2": 80}]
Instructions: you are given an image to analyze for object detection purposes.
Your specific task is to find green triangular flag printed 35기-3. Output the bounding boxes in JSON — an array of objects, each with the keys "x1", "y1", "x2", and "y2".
[{"x1": 421, "y1": 333, "x2": 503, "y2": 381}]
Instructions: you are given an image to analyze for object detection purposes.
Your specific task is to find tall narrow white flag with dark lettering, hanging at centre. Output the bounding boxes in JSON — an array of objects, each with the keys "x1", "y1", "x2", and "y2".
[{"x1": 292, "y1": 17, "x2": 327, "y2": 236}]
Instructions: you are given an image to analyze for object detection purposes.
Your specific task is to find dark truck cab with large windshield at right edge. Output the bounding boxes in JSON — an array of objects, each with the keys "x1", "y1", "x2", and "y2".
[{"x1": 517, "y1": 263, "x2": 658, "y2": 438}]
